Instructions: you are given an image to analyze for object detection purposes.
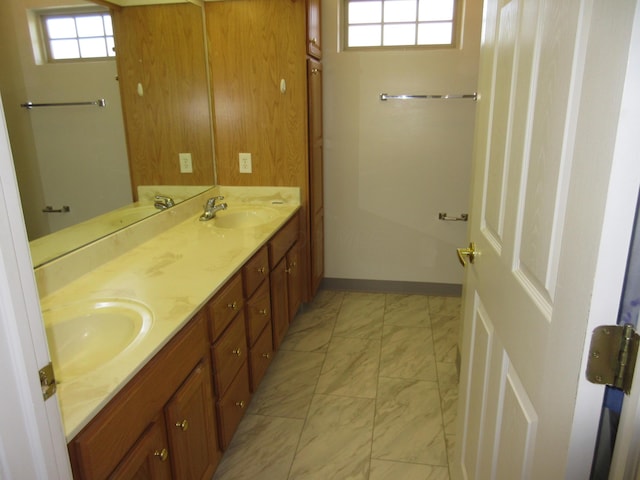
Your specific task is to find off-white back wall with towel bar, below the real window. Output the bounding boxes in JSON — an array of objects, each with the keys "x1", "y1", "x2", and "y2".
[{"x1": 322, "y1": 0, "x2": 482, "y2": 284}]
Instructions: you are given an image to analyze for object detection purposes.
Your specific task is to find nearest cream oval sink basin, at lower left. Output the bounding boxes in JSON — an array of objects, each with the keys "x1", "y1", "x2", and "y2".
[{"x1": 43, "y1": 299, "x2": 153, "y2": 383}]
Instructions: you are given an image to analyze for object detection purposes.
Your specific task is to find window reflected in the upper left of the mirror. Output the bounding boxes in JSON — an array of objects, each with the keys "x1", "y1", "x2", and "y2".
[{"x1": 40, "y1": 12, "x2": 115, "y2": 62}]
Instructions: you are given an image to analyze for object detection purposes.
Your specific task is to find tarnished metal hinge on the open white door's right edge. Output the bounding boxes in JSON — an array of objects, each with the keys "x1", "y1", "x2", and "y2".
[{"x1": 587, "y1": 324, "x2": 640, "y2": 394}]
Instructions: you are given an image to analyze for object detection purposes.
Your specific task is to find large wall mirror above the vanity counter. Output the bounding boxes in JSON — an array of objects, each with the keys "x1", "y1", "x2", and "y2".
[{"x1": 0, "y1": 0, "x2": 215, "y2": 267}]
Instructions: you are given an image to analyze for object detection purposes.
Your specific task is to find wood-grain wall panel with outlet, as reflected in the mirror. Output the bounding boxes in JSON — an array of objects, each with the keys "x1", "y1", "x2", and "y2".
[{"x1": 113, "y1": 3, "x2": 214, "y2": 195}]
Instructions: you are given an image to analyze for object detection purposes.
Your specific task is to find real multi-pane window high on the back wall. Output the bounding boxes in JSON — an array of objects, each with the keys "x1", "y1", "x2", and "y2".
[{"x1": 344, "y1": 0, "x2": 458, "y2": 48}]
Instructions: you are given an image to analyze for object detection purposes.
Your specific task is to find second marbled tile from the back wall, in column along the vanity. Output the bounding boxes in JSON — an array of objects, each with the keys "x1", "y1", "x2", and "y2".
[{"x1": 280, "y1": 309, "x2": 336, "y2": 352}]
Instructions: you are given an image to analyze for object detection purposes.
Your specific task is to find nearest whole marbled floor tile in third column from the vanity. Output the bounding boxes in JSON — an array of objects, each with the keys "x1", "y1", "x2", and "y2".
[{"x1": 371, "y1": 377, "x2": 447, "y2": 466}]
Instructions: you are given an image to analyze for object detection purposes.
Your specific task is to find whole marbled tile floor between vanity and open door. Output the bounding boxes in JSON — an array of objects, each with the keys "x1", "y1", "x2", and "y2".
[{"x1": 214, "y1": 290, "x2": 460, "y2": 480}]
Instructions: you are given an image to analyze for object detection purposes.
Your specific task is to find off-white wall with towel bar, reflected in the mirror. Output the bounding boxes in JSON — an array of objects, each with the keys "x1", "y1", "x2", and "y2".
[{"x1": 0, "y1": 0, "x2": 132, "y2": 239}]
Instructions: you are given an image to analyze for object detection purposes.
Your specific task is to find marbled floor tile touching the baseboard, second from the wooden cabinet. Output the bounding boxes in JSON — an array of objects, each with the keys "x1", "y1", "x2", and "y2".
[{"x1": 333, "y1": 292, "x2": 385, "y2": 338}]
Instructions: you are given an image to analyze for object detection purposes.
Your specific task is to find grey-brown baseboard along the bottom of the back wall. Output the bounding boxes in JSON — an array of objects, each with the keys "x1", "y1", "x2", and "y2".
[{"x1": 320, "y1": 278, "x2": 462, "y2": 297}]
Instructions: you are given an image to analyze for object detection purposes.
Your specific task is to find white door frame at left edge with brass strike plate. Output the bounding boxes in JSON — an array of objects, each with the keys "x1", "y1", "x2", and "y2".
[{"x1": 0, "y1": 94, "x2": 71, "y2": 480}]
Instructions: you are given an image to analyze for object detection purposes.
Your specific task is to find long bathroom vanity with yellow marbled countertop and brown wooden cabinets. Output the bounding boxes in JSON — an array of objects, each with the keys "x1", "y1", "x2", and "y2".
[{"x1": 36, "y1": 187, "x2": 301, "y2": 479}]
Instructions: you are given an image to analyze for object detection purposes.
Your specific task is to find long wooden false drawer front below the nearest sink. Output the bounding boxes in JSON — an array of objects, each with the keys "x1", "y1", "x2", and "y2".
[{"x1": 69, "y1": 312, "x2": 208, "y2": 478}]
